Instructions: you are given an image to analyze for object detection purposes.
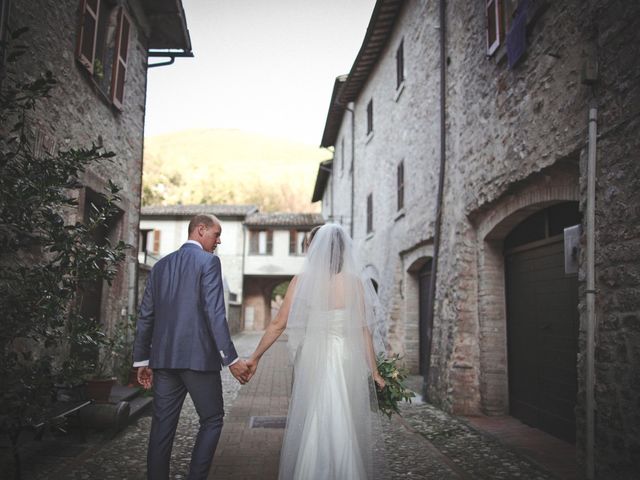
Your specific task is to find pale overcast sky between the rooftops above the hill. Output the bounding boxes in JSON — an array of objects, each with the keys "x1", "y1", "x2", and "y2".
[{"x1": 145, "y1": 0, "x2": 375, "y2": 146}]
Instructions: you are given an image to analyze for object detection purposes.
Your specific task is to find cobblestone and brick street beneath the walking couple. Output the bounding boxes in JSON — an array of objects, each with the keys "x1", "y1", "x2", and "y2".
[{"x1": 3, "y1": 333, "x2": 577, "y2": 480}]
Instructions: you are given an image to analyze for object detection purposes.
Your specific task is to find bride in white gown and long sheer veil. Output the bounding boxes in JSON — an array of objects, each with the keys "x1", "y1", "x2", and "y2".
[{"x1": 247, "y1": 224, "x2": 387, "y2": 480}]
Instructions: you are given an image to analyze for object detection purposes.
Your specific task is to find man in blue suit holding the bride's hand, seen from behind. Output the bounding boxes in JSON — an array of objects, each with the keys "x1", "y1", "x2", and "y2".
[{"x1": 133, "y1": 215, "x2": 248, "y2": 480}]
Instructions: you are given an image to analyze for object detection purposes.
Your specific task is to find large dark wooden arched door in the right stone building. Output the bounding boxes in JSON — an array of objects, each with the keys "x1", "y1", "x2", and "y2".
[{"x1": 504, "y1": 202, "x2": 580, "y2": 442}]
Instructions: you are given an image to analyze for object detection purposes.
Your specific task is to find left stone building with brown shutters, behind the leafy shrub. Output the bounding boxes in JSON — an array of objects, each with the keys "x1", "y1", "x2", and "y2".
[{"x1": 0, "y1": 0, "x2": 191, "y2": 336}]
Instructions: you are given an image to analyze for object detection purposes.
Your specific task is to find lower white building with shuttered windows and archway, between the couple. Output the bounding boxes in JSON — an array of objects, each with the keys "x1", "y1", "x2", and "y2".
[{"x1": 242, "y1": 213, "x2": 324, "y2": 330}]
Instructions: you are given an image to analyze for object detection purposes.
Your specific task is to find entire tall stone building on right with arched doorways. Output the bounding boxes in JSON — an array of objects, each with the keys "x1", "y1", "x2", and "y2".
[{"x1": 314, "y1": 0, "x2": 640, "y2": 478}]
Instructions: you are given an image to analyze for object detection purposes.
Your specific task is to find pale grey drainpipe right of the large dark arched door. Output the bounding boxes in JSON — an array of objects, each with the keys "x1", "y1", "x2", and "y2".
[{"x1": 585, "y1": 102, "x2": 598, "y2": 480}]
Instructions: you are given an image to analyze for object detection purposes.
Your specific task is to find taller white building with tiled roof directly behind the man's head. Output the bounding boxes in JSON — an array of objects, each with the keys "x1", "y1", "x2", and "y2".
[{"x1": 138, "y1": 205, "x2": 258, "y2": 333}]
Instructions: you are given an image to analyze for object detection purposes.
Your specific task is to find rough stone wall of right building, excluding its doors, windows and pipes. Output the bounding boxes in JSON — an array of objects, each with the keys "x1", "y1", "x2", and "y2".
[{"x1": 324, "y1": 0, "x2": 640, "y2": 478}]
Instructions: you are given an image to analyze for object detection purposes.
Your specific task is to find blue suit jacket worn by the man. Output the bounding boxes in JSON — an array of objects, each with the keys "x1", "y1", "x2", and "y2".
[{"x1": 133, "y1": 243, "x2": 238, "y2": 371}]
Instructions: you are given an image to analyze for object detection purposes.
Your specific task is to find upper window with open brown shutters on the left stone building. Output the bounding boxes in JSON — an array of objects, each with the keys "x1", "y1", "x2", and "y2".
[{"x1": 76, "y1": 0, "x2": 131, "y2": 110}]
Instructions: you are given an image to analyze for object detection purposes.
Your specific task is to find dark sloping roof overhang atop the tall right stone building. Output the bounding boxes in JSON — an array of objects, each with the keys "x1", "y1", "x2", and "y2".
[{"x1": 321, "y1": 0, "x2": 404, "y2": 147}]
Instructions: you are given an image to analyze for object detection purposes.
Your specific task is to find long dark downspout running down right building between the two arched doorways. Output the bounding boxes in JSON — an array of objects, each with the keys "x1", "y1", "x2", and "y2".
[{"x1": 423, "y1": 0, "x2": 447, "y2": 396}]
